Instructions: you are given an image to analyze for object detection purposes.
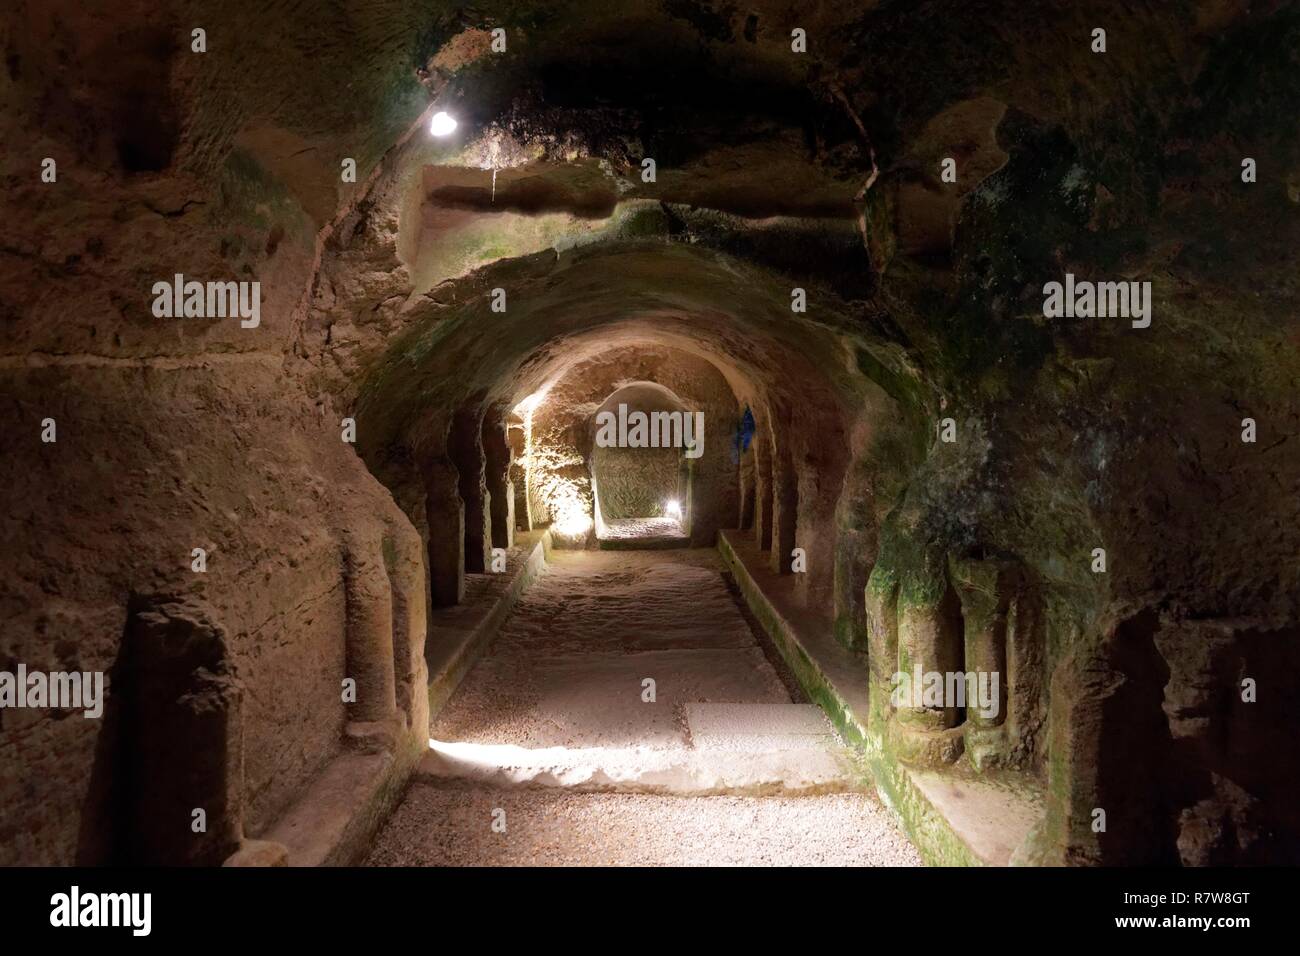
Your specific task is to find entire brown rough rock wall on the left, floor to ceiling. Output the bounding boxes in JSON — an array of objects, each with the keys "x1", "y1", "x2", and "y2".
[{"x1": 0, "y1": 3, "x2": 447, "y2": 864}]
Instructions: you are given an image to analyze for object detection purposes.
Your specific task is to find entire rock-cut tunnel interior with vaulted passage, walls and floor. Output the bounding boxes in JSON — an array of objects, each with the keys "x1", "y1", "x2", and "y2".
[{"x1": 0, "y1": 0, "x2": 1300, "y2": 866}]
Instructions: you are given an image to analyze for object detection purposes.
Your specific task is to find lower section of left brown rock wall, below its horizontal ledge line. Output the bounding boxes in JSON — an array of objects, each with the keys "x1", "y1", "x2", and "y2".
[{"x1": 3, "y1": 356, "x2": 413, "y2": 862}]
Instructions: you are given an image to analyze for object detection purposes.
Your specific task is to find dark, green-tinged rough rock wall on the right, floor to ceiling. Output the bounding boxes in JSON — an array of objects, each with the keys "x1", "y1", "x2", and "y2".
[{"x1": 862, "y1": 5, "x2": 1300, "y2": 864}]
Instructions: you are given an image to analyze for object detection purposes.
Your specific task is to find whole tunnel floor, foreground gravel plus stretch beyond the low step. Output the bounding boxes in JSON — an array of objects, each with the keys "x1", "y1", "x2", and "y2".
[{"x1": 369, "y1": 549, "x2": 920, "y2": 866}]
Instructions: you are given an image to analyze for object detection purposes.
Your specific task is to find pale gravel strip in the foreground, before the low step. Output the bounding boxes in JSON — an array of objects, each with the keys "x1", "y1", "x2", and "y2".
[{"x1": 367, "y1": 784, "x2": 920, "y2": 866}]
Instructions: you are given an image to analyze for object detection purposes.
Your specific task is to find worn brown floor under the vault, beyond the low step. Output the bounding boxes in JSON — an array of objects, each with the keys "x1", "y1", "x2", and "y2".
[{"x1": 430, "y1": 549, "x2": 790, "y2": 749}]
